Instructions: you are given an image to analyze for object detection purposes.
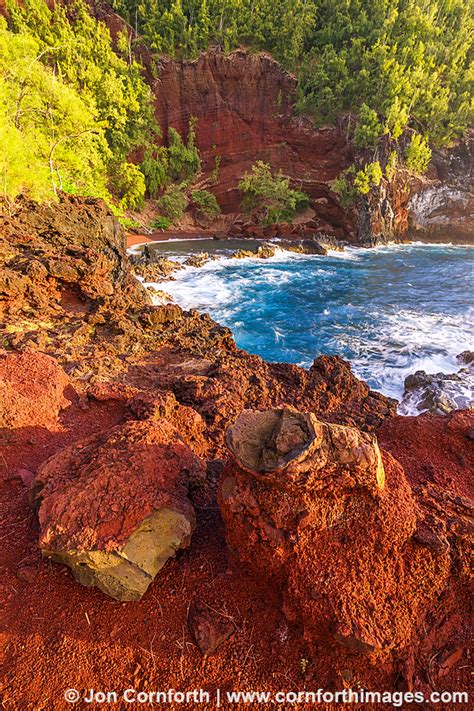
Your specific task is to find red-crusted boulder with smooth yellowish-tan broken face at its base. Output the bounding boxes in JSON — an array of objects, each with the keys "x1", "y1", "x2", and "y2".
[{"x1": 33, "y1": 419, "x2": 203, "y2": 600}]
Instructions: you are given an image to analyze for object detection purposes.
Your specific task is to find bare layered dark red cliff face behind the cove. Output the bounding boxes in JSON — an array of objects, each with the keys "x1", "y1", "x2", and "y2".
[{"x1": 154, "y1": 50, "x2": 350, "y2": 234}]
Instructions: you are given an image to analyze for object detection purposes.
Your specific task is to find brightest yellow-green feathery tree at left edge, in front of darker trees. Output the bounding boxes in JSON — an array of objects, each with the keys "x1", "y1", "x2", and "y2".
[{"x1": 0, "y1": 18, "x2": 110, "y2": 200}]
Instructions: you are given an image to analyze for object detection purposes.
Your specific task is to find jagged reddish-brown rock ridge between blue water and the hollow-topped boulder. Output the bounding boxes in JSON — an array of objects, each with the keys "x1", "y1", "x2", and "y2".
[{"x1": 152, "y1": 351, "x2": 396, "y2": 458}]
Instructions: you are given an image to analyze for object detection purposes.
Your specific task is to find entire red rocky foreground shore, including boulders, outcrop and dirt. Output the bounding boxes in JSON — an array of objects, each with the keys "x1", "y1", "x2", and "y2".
[{"x1": 0, "y1": 197, "x2": 474, "y2": 707}]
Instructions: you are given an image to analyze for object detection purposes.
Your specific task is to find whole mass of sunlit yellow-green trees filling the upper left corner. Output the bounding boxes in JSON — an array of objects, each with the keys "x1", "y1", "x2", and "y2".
[{"x1": 0, "y1": 0, "x2": 157, "y2": 208}]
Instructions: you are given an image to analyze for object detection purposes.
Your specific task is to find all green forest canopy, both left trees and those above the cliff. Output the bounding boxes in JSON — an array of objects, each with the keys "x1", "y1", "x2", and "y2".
[{"x1": 0, "y1": 0, "x2": 474, "y2": 214}]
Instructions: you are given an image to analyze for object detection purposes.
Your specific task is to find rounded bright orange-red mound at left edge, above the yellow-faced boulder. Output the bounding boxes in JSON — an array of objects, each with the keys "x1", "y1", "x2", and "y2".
[{"x1": 0, "y1": 351, "x2": 70, "y2": 428}]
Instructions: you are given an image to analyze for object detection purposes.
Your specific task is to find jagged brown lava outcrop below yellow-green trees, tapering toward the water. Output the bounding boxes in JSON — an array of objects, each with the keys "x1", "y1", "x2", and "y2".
[{"x1": 0, "y1": 196, "x2": 241, "y2": 381}]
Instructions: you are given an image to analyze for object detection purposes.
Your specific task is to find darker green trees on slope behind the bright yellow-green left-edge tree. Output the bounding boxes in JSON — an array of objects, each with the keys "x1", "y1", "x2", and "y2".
[{"x1": 7, "y1": 0, "x2": 157, "y2": 162}]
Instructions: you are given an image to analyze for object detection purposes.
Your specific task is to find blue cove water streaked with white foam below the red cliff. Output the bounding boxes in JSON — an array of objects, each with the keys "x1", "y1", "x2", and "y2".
[{"x1": 130, "y1": 239, "x2": 474, "y2": 406}]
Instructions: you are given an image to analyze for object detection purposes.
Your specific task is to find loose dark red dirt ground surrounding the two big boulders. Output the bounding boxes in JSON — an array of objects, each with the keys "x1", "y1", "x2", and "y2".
[{"x1": 0, "y1": 358, "x2": 474, "y2": 710}]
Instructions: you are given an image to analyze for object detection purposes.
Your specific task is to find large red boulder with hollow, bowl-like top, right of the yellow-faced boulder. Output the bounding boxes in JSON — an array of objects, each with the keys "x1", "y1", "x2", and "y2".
[{"x1": 220, "y1": 409, "x2": 450, "y2": 661}]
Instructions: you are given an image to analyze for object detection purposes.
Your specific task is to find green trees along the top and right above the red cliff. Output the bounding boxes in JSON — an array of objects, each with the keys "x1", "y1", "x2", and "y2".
[{"x1": 112, "y1": 0, "x2": 474, "y2": 152}]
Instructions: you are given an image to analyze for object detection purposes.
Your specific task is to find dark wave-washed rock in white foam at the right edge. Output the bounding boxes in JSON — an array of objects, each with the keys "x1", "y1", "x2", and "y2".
[{"x1": 400, "y1": 351, "x2": 474, "y2": 415}]
